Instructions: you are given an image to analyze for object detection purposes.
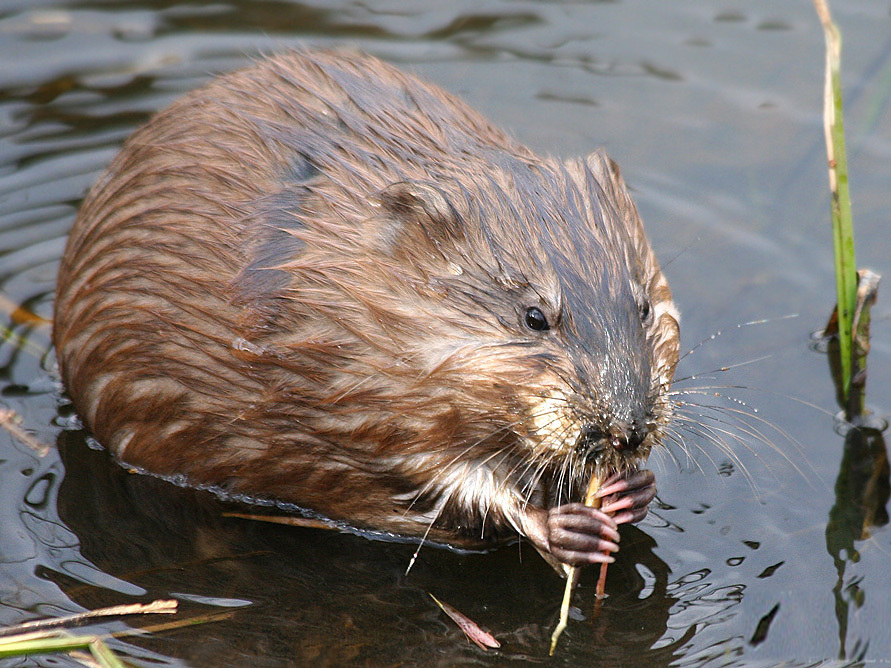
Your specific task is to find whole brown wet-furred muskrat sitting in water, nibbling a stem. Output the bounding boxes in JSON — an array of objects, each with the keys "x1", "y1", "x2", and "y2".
[{"x1": 53, "y1": 51, "x2": 679, "y2": 564}]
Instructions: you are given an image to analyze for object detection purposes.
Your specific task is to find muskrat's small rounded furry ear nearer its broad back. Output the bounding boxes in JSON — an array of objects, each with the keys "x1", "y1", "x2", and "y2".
[{"x1": 376, "y1": 181, "x2": 465, "y2": 252}]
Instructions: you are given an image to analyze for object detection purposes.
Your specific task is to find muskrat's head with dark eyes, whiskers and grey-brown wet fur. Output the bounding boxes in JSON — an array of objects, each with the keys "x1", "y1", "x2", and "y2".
[{"x1": 330, "y1": 154, "x2": 678, "y2": 503}]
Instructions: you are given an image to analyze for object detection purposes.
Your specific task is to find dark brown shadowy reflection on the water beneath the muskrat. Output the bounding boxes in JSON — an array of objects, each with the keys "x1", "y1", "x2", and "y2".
[{"x1": 48, "y1": 431, "x2": 684, "y2": 666}]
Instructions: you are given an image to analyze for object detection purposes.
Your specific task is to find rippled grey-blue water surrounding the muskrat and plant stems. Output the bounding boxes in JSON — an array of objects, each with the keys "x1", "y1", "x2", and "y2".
[{"x1": 0, "y1": 0, "x2": 891, "y2": 667}]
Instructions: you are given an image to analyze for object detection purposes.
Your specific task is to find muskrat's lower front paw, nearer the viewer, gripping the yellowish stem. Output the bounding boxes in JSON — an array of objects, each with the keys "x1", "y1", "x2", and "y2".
[{"x1": 548, "y1": 503, "x2": 619, "y2": 566}]
